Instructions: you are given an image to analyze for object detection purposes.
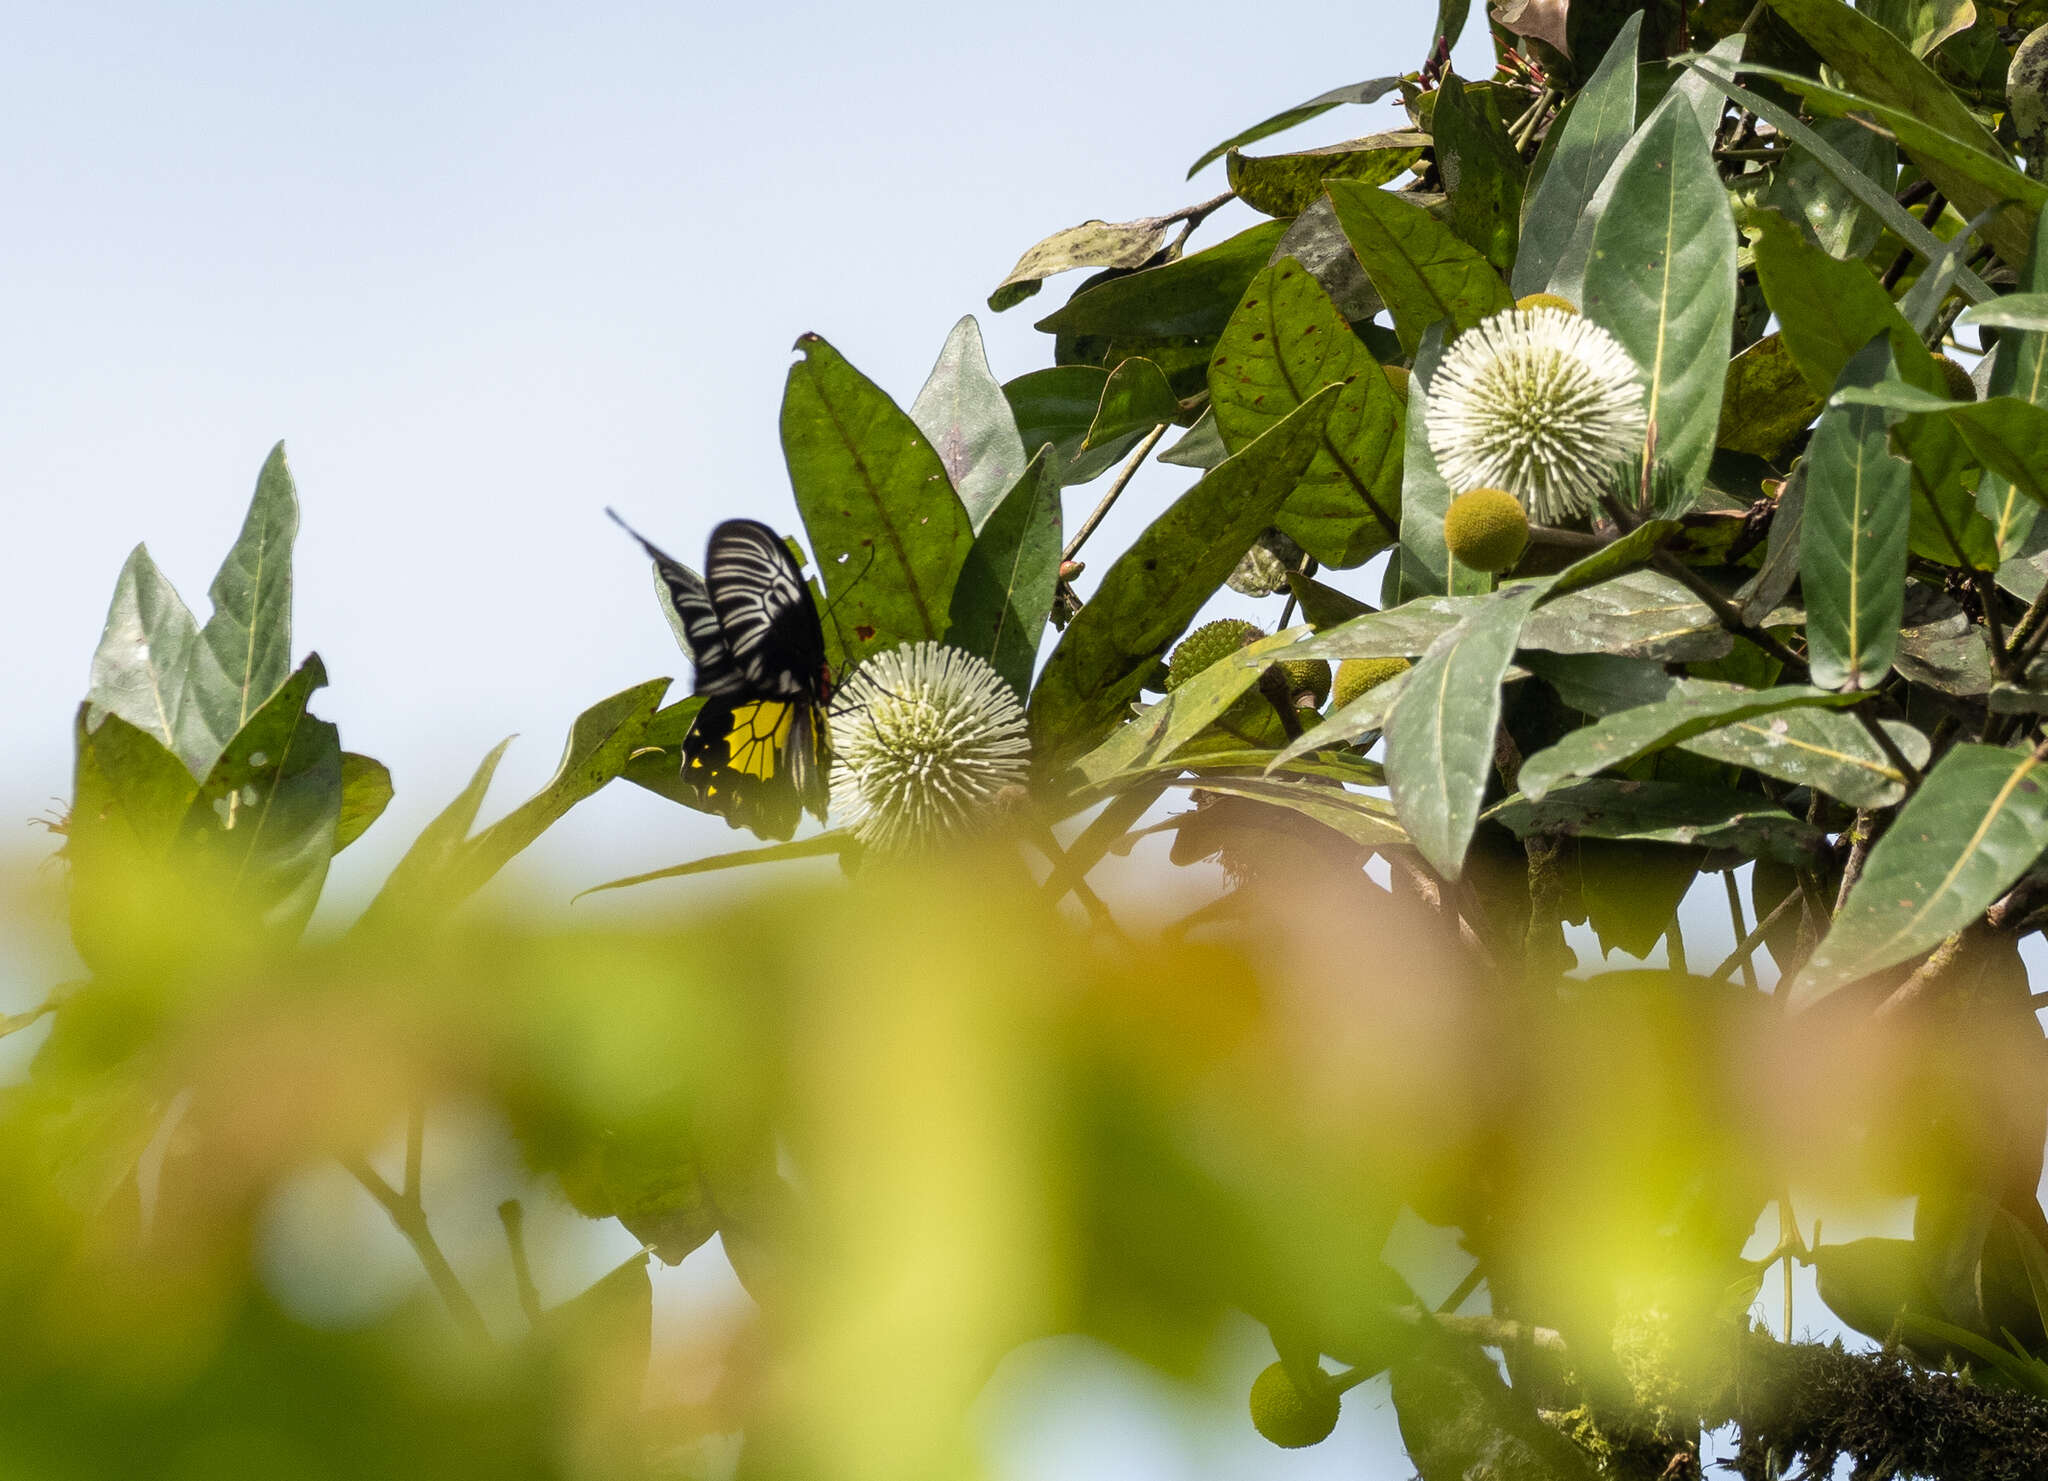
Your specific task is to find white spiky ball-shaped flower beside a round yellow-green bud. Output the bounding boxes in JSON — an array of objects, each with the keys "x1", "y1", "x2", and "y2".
[{"x1": 1423, "y1": 309, "x2": 1647, "y2": 524}]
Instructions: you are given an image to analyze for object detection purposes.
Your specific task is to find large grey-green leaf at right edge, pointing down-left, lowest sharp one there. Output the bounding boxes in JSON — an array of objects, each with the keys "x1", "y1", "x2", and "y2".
[{"x1": 1792, "y1": 746, "x2": 2048, "y2": 1008}]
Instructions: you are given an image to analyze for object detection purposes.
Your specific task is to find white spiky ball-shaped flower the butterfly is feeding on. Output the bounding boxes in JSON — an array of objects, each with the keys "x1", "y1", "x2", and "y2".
[{"x1": 831, "y1": 643, "x2": 1030, "y2": 854}]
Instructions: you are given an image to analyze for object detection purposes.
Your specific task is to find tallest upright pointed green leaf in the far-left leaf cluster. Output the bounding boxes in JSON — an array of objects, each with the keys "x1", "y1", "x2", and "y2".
[{"x1": 178, "y1": 442, "x2": 299, "y2": 774}]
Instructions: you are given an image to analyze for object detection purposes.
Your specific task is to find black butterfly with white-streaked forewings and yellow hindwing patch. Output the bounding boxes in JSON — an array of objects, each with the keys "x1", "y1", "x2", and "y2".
[{"x1": 606, "y1": 510, "x2": 831, "y2": 838}]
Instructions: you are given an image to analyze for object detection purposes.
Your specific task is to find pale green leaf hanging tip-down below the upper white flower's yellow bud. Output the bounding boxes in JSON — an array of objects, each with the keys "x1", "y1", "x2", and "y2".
[{"x1": 1386, "y1": 582, "x2": 1544, "y2": 879}]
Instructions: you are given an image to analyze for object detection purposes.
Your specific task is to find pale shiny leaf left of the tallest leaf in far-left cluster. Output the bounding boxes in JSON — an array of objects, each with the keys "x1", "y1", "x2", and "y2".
[{"x1": 86, "y1": 545, "x2": 213, "y2": 776}]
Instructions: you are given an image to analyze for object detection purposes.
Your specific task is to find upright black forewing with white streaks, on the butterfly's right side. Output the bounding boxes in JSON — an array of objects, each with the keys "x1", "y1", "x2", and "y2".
[{"x1": 705, "y1": 520, "x2": 825, "y2": 699}]
